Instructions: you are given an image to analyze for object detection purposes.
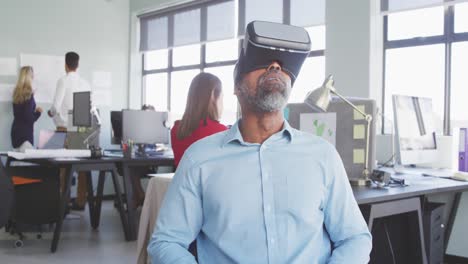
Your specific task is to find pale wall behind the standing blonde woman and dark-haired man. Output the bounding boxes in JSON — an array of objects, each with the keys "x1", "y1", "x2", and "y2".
[{"x1": 0, "y1": 0, "x2": 130, "y2": 150}]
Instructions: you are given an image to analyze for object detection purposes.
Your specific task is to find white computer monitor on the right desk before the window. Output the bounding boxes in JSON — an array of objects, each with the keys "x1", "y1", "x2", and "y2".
[{"x1": 393, "y1": 95, "x2": 437, "y2": 165}]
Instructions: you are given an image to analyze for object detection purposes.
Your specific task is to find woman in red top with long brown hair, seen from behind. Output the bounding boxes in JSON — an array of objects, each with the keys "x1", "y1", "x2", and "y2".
[{"x1": 171, "y1": 72, "x2": 227, "y2": 167}]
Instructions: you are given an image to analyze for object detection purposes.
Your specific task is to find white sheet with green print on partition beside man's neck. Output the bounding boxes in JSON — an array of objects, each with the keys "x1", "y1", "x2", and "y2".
[{"x1": 299, "y1": 113, "x2": 336, "y2": 146}]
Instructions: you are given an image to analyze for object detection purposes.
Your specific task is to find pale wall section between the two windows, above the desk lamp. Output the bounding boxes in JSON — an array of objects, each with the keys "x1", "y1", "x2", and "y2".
[{"x1": 325, "y1": 0, "x2": 383, "y2": 105}]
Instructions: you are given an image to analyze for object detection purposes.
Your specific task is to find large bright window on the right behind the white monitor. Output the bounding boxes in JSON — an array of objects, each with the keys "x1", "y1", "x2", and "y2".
[{"x1": 382, "y1": 0, "x2": 468, "y2": 134}]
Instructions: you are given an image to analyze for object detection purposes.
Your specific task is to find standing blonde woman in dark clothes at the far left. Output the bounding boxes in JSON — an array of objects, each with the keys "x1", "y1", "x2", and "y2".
[{"x1": 11, "y1": 66, "x2": 42, "y2": 150}]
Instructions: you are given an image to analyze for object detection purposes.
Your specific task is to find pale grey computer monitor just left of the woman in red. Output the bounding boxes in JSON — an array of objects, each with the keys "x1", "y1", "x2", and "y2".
[{"x1": 122, "y1": 110, "x2": 169, "y2": 144}]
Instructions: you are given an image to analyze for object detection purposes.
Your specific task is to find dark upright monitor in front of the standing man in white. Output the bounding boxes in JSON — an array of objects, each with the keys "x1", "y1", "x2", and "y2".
[{"x1": 73, "y1": 92, "x2": 92, "y2": 127}]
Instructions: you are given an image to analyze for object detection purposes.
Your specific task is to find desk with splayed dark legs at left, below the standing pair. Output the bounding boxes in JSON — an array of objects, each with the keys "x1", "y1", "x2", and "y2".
[{"x1": 6, "y1": 158, "x2": 129, "y2": 252}]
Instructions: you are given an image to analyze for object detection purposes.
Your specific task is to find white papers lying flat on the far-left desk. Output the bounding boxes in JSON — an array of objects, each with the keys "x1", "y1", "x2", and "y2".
[{"x1": 8, "y1": 149, "x2": 91, "y2": 160}]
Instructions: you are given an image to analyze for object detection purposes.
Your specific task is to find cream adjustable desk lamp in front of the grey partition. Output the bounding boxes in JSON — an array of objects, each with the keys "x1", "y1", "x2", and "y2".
[{"x1": 304, "y1": 75, "x2": 372, "y2": 186}]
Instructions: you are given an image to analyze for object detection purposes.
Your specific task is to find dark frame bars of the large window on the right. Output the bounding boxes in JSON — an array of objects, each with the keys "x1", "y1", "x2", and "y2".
[{"x1": 381, "y1": 0, "x2": 468, "y2": 135}]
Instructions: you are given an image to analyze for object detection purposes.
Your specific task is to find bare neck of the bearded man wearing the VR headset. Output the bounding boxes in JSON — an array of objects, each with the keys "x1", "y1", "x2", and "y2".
[{"x1": 239, "y1": 111, "x2": 284, "y2": 144}]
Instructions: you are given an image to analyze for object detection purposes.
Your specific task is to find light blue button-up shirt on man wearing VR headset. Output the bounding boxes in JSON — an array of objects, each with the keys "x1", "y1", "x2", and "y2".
[{"x1": 148, "y1": 121, "x2": 372, "y2": 264}]
